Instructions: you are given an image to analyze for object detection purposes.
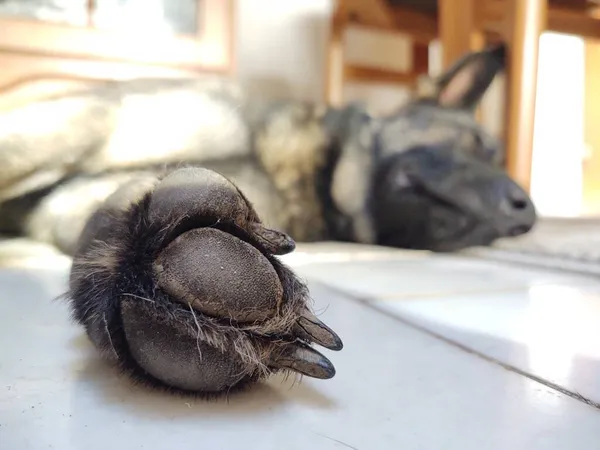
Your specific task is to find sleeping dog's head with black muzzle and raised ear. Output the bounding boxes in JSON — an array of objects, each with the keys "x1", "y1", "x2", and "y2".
[{"x1": 332, "y1": 47, "x2": 536, "y2": 251}]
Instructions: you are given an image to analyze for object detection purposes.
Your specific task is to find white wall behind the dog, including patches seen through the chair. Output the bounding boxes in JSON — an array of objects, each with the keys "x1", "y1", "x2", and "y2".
[{"x1": 236, "y1": 0, "x2": 410, "y2": 113}]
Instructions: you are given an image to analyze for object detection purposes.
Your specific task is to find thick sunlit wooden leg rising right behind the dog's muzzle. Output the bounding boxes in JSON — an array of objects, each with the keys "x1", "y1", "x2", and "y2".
[{"x1": 505, "y1": 0, "x2": 548, "y2": 191}]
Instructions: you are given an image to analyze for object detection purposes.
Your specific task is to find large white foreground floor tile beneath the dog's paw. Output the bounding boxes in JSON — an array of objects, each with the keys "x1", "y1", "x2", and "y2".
[{"x1": 0, "y1": 270, "x2": 600, "y2": 450}]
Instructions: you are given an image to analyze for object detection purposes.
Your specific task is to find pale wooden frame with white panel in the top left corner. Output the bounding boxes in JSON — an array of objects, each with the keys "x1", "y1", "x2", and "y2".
[{"x1": 0, "y1": 0, "x2": 234, "y2": 107}]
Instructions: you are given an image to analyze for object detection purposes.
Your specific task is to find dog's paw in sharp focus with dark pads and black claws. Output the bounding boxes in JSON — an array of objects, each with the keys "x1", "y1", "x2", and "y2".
[{"x1": 68, "y1": 168, "x2": 342, "y2": 395}]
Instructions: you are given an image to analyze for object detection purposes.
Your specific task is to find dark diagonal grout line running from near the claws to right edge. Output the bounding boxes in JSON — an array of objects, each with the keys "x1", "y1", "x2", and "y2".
[{"x1": 317, "y1": 281, "x2": 600, "y2": 411}]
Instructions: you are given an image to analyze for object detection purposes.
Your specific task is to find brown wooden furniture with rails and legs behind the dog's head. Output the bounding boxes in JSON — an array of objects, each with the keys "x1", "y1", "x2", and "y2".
[{"x1": 326, "y1": 0, "x2": 600, "y2": 189}]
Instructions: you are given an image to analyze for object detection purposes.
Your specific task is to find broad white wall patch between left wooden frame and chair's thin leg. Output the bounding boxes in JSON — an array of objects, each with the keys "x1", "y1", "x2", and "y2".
[{"x1": 236, "y1": 0, "x2": 333, "y2": 100}]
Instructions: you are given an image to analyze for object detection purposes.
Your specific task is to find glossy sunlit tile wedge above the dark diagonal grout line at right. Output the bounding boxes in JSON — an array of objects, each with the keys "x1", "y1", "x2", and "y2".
[{"x1": 377, "y1": 283, "x2": 600, "y2": 403}]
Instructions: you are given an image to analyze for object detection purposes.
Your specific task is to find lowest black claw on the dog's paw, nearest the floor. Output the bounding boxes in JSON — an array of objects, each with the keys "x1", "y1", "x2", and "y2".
[{"x1": 272, "y1": 344, "x2": 335, "y2": 380}]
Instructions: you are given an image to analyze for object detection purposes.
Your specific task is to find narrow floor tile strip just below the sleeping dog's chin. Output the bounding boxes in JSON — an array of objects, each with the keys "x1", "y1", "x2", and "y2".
[{"x1": 290, "y1": 254, "x2": 594, "y2": 298}]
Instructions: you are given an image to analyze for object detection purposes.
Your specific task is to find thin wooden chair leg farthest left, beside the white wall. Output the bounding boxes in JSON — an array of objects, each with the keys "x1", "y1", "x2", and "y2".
[{"x1": 325, "y1": 1, "x2": 347, "y2": 106}]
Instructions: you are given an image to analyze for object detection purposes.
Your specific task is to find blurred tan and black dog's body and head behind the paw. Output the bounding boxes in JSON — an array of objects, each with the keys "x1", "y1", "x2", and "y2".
[{"x1": 0, "y1": 47, "x2": 535, "y2": 254}]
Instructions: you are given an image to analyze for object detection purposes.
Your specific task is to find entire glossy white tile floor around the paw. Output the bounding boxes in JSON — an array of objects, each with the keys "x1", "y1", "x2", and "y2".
[{"x1": 0, "y1": 245, "x2": 600, "y2": 450}]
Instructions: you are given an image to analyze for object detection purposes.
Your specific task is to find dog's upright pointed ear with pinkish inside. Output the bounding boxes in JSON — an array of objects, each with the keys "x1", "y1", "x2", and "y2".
[{"x1": 435, "y1": 44, "x2": 506, "y2": 111}]
